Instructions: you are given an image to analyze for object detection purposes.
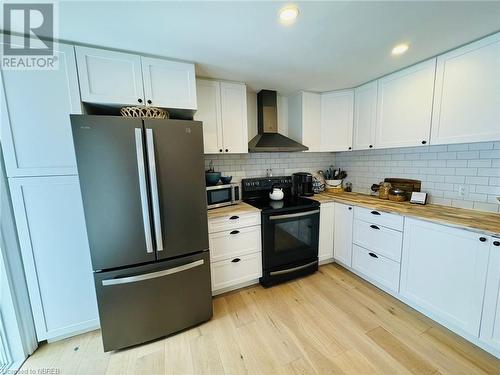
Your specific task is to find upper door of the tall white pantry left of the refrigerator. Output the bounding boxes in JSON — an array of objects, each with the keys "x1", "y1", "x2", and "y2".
[{"x1": 0, "y1": 44, "x2": 81, "y2": 177}]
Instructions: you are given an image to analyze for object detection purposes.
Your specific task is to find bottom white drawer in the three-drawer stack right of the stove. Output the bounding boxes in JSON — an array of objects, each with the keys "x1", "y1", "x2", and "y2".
[{"x1": 352, "y1": 245, "x2": 400, "y2": 293}]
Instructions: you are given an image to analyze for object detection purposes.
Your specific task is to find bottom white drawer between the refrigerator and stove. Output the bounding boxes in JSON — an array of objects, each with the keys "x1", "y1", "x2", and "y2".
[{"x1": 211, "y1": 252, "x2": 262, "y2": 293}]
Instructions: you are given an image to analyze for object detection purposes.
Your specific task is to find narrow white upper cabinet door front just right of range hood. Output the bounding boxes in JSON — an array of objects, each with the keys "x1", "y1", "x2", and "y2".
[{"x1": 299, "y1": 92, "x2": 321, "y2": 152}]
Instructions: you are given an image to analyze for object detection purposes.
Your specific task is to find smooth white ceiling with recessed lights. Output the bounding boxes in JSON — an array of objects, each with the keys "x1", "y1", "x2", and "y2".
[{"x1": 55, "y1": 1, "x2": 500, "y2": 94}]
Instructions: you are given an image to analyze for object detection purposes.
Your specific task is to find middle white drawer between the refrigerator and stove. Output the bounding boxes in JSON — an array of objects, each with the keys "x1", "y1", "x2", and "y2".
[{"x1": 209, "y1": 226, "x2": 261, "y2": 262}]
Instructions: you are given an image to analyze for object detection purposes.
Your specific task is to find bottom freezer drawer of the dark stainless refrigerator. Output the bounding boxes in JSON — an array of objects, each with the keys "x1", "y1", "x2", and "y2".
[{"x1": 94, "y1": 251, "x2": 212, "y2": 351}]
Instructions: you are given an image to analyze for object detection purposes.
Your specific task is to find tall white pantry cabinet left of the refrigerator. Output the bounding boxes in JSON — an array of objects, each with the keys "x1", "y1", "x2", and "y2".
[{"x1": 0, "y1": 44, "x2": 99, "y2": 341}]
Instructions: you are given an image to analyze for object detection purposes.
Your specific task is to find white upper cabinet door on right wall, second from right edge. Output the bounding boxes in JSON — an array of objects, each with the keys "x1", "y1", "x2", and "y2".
[{"x1": 375, "y1": 59, "x2": 436, "y2": 148}]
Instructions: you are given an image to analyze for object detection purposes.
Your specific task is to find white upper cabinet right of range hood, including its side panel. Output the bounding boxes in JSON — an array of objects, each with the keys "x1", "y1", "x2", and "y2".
[{"x1": 288, "y1": 91, "x2": 321, "y2": 151}]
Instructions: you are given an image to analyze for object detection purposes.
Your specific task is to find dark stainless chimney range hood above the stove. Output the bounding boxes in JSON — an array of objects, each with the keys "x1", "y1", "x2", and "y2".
[{"x1": 248, "y1": 90, "x2": 309, "y2": 152}]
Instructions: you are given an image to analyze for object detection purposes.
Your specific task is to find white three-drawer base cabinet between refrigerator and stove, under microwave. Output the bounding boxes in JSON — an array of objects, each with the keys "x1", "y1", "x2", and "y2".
[{"x1": 208, "y1": 212, "x2": 262, "y2": 295}]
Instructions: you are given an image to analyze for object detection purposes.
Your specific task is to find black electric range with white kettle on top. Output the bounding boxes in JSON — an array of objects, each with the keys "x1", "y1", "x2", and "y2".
[{"x1": 241, "y1": 176, "x2": 320, "y2": 287}]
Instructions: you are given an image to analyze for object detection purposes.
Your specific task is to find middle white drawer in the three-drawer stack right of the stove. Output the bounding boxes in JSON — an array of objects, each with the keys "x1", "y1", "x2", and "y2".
[{"x1": 353, "y1": 219, "x2": 403, "y2": 262}]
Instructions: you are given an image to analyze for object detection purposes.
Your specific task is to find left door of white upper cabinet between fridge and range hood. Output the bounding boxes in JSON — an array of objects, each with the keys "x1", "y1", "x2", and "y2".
[{"x1": 194, "y1": 79, "x2": 223, "y2": 154}]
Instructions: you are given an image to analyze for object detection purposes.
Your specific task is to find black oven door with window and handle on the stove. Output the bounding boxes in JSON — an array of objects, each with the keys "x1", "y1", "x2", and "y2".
[{"x1": 262, "y1": 207, "x2": 319, "y2": 274}]
